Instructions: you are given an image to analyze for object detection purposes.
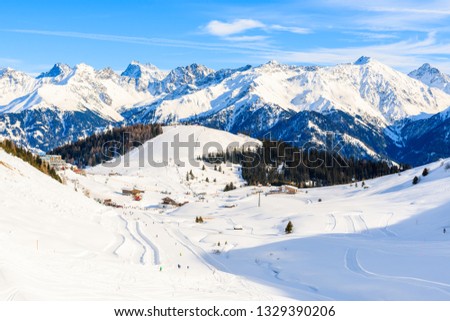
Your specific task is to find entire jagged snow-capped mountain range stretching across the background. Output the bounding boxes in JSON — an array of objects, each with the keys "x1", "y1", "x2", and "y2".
[{"x1": 0, "y1": 57, "x2": 450, "y2": 165}]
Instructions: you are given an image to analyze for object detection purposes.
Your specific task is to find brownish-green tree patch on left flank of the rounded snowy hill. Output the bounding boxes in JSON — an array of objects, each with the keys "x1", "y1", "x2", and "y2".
[{"x1": 48, "y1": 124, "x2": 162, "y2": 167}]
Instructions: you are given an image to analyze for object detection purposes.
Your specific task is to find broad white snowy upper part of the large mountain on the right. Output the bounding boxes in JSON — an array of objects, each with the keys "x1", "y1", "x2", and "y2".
[{"x1": 127, "y1": 57, "x2": 450, "y2": 128}]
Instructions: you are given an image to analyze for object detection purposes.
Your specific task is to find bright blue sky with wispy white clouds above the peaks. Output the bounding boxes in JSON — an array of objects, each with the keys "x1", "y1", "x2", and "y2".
[{"x1": 0, "y1": 0, "x2": 450, "y2": 74}]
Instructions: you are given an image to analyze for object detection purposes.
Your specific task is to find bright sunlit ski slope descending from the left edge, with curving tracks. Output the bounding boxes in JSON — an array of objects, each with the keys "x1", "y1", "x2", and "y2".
[{"x1": 0, "y1": 141, "x2": 281, "y2": 300}]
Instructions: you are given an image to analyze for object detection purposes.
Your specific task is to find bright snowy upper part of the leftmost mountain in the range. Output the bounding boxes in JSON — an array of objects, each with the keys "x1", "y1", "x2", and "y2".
[{"x1": 0, "y1": 64, "x2": 157, "y2": 117}]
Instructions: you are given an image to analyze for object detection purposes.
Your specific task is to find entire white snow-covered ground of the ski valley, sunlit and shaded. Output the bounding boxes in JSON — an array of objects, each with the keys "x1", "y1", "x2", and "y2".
[{"x1": 0, "y1": 126, "x2": 450, "y2": 300}]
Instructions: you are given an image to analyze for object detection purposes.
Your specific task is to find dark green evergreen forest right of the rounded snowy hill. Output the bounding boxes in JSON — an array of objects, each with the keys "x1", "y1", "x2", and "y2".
[{"x1": 205, "y1": 141, "x2": 410, "y2": 187}]
